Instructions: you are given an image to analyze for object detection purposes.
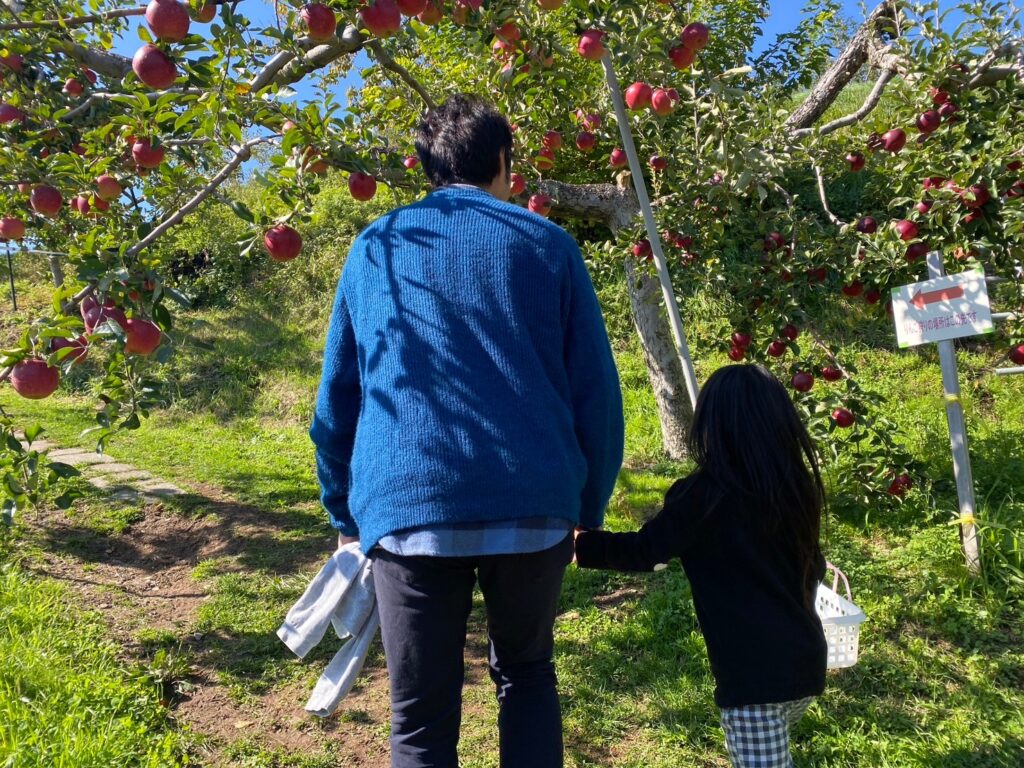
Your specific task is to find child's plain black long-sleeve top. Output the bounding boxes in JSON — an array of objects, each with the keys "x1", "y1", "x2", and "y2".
[{"x1": 577, "y1": 472, "x2": 826, "y2": 707}]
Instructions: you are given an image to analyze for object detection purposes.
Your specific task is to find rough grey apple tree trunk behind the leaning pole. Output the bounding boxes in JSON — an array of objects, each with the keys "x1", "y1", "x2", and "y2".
[{"x1": 626, "y1": 257, "x2": 693, "y2": 461}]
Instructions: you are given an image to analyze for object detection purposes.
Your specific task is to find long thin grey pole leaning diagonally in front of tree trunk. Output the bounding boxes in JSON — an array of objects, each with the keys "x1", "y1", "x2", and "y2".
[{"x1": 601, "y1": 50, "x2": 699, "y2": 408}]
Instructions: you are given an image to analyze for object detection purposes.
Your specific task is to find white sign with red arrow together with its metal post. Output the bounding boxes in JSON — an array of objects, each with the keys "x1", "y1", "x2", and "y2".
[{"x1": 892, "y1": 256, "x2": 993, "y2": 574}]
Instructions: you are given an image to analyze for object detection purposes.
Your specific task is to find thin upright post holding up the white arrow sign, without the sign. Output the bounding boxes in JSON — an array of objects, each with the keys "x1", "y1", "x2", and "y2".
[{"x1": 928, "y1": 251, "x2": 981, "y2": 575}]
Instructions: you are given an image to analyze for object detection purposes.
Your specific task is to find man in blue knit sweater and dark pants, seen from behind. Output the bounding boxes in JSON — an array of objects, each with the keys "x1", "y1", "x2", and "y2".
[{"x1": 310, "y1": 96, "x2": 624, "y2": 768}]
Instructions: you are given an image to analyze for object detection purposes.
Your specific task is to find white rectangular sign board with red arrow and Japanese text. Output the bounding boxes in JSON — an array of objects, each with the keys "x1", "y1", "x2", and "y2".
[{"x1": 893, "y1": 271, "x2": 992, "y2": 347}]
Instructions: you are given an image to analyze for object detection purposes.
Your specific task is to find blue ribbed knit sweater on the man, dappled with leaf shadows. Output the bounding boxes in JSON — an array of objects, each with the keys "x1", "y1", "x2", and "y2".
[{"x1": 309, "y1": 186, "x2": 624, "y2": 552}]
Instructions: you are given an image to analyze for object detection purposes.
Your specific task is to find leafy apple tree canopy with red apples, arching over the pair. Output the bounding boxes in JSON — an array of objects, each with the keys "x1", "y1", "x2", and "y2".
[{"x1": 0, "y1": 0, "x2": 1024, "y2": 524}]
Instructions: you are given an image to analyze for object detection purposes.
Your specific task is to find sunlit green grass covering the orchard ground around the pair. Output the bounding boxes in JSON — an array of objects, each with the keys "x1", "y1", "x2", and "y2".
[{"x1": 0, "y1": 247, "x2": 1024, "y2": 768}]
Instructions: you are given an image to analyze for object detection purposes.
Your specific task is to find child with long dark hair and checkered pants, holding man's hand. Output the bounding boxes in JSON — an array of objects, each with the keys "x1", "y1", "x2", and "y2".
[{"x1": 575, "y1": 365, "x2": 826, "y2": 768}]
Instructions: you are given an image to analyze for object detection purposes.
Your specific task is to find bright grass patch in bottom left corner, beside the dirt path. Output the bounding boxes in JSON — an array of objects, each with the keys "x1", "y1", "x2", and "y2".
[{"x1": 0, "y1": 563, "x2": 187, "y2": 768}]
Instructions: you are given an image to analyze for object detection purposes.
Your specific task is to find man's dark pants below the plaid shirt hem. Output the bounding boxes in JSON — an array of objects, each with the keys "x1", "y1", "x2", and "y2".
[{"x1": 372, "y1": 535, "x2": 572, "y2": 768}]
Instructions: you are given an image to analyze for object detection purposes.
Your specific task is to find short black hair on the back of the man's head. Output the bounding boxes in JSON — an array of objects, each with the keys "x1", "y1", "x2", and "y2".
[{"x1": 416, "y1": 94, "x2": 512, "y2": 186}]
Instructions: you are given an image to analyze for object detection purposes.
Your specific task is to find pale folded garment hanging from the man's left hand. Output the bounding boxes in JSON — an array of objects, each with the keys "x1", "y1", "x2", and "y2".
[{"x1": 278, "y1": 542, "x2": 380, "y2": 717}]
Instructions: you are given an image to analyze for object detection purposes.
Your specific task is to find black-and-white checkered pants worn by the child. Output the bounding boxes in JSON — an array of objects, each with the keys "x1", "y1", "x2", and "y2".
[{"x1": 722, "y1": 696, "x2": 814, "y2": 768}]
